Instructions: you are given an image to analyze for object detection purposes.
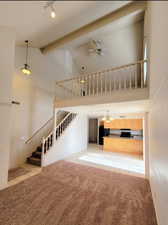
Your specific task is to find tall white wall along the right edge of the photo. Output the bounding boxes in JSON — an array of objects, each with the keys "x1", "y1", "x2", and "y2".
[{"x1": 148, "y1": 1, "x2": 168, "y2": 225}]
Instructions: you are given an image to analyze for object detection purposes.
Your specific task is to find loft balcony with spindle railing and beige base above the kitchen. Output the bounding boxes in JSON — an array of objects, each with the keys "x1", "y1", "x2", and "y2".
[{"x1": 55, "y1": 60, "x2": 149, "y2": 108}]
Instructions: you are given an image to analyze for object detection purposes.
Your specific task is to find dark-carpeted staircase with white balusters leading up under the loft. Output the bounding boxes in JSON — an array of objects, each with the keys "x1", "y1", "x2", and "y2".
[{"x1": 27, "y1": 113, "x2": 76, "y2": 166}]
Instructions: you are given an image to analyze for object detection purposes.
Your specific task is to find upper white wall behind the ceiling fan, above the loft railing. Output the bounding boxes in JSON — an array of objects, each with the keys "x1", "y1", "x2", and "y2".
[{"x1": 71, "y1": 21, "x2": 143, "y2": 73}]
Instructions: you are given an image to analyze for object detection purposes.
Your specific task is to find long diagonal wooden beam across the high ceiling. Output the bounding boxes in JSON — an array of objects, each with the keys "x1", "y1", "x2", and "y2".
[{"x1": 40, "y1": 1, "x2": 146, "y2": 54}]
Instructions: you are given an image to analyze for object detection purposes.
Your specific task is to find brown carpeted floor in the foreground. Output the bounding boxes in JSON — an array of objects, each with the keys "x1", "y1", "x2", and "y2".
[{"x1": 0, "y1": 161, "x2": 157, "y2": 225}]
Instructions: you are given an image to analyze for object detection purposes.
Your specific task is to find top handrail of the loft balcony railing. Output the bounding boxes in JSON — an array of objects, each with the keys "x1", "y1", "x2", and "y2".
[{"x1": 56, "y1": 59, "x2": 148, "y2": 85}]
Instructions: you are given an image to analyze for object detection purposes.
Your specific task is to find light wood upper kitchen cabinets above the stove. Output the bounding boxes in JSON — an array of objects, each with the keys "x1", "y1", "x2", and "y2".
[{"x1": 104, "y1": 119, "x2": 143, "y2": 130}]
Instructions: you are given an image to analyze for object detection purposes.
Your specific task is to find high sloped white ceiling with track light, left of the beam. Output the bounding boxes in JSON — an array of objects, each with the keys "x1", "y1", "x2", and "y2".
[{"x1": 0, "y1": 1, "x2": 129, "y2": 47}]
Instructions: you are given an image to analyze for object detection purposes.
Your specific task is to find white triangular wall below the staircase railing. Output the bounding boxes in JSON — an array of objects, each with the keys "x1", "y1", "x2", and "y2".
[{"x1": 43, "y1": 115, "x2": 88, "y2": 166}]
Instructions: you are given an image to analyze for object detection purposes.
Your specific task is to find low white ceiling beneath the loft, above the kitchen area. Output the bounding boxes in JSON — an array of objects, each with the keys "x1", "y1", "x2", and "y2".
[{"x1": 62, "y1": 100, "x2": 150, "y2": 118}]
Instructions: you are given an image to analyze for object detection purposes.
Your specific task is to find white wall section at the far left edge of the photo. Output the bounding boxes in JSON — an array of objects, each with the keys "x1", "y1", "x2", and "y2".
[{"x1": 0, "y1": 27, "x2": 15, "y2": 189}]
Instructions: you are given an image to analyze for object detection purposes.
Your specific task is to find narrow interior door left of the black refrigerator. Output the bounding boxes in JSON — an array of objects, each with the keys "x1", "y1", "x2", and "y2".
[{"x1": 89, "y1": 119, "x2": 98, "y2": 144}]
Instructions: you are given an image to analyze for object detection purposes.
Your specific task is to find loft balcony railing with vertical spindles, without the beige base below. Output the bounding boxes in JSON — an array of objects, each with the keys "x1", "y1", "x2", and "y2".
[{"x1": 56, "y1": 60, "x2": 148, "y2": 100}]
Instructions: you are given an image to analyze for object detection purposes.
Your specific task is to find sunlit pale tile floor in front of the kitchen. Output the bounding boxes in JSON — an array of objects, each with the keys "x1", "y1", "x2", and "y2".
[{"x1": 66, "y1": 144, "x2": 145, "y2": 177}]
